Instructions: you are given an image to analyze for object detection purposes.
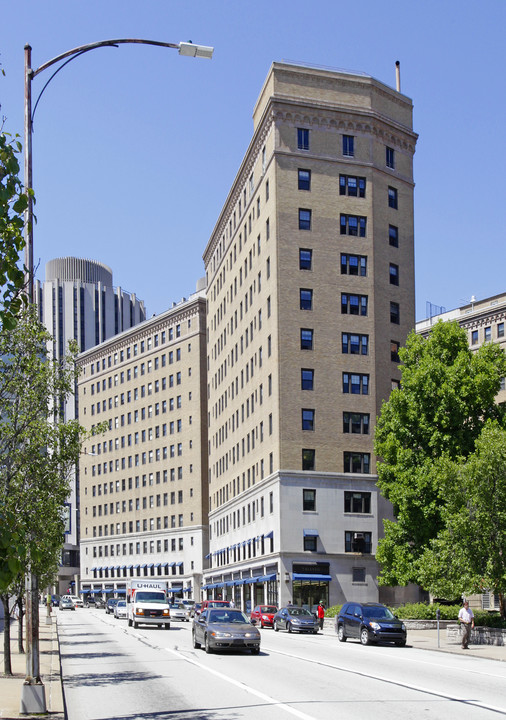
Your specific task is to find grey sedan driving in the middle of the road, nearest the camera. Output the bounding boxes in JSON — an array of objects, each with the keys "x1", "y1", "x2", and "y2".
[{"x1": 192, "y1": 607, "x2": 260, "y2": 655}]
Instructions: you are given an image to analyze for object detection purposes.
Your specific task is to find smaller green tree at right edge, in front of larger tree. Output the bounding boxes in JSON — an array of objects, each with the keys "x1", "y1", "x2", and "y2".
[{"x1": 419, "y1": 421, "x2": 506, "y2": 618}]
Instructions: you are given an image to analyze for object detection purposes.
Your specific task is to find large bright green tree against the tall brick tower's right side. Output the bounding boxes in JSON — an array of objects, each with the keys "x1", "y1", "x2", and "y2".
[{"x1": 375, "y1": 321, "x2": 506, "y2": 585}]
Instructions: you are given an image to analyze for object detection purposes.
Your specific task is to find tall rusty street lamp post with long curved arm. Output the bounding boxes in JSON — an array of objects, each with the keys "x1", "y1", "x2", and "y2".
[{"x1": 20, "y1": 38, "x2": 214, "y2": 714}]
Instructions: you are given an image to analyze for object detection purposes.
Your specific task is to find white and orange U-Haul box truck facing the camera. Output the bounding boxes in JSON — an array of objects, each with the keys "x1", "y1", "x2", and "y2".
[{"x1": 126, "y1": 578, "x2": 170, "y2": 630}]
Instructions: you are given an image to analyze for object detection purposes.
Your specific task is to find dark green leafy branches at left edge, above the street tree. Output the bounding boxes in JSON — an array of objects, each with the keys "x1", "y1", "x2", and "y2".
[{"x1": 0, "y1": 132, "x2": 33, "y2": 329}]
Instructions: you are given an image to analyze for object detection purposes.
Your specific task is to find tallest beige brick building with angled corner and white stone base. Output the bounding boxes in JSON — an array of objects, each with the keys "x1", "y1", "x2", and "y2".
[{"x1": 204, "y1": 63, "x2": 417, "y2": 607}]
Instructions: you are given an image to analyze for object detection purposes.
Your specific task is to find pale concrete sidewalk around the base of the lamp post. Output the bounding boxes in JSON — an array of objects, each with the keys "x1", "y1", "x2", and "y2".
[{"x1": 0, "y1": 611, "x2": 65, "y2": 720}]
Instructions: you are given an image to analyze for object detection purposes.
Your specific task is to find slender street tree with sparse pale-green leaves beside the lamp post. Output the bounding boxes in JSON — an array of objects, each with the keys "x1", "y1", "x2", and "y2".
[{"x1": 0, "y1": 308, "x2": 81, "y2": 672}]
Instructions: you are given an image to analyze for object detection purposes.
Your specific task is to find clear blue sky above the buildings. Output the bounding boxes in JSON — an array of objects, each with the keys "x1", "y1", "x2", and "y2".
[{"x1": 0, "y1": 0, "x2": 506, "y2": 319}]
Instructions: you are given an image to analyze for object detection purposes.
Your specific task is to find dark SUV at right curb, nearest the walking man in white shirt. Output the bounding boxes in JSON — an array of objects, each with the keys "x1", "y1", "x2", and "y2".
[{"x1": 336, "y1": 602, "x2": 406, "y2": 646}]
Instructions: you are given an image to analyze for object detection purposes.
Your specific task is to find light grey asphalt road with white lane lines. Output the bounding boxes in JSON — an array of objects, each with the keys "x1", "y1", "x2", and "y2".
[{"x1": 58, "y1": 609, "x2": 506, "y2": 720}]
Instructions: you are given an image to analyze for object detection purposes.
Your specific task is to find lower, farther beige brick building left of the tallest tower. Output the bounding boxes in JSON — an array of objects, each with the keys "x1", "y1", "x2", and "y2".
[{"x1": 75, "y1": 293, "x2": 208, "y2": 597}]
